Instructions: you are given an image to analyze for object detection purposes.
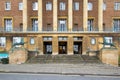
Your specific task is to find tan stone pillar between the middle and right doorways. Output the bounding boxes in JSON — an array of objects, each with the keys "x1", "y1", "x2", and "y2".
[{"x1": 67, "y1": 36, "x2": 73, "y2": 55}]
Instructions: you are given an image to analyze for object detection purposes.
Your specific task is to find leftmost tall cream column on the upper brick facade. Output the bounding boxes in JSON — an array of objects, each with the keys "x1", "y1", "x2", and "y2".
[{"x1": 23, "y1": 0, "x2": 28, "y2": 31}]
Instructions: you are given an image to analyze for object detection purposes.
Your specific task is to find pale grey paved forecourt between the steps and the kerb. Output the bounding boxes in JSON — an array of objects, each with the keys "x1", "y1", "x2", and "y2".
[{"x1": 0, "y1": 63, "x2": 120, "y2": 76}]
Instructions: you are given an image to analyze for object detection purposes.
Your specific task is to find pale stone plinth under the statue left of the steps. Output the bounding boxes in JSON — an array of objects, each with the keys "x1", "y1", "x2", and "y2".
[{"x1": 9, "y1": 47, "x2": 28, "y2": 64}]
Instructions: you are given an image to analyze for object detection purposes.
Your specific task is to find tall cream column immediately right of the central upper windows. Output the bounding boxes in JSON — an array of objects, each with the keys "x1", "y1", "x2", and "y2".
[{"x1": 68, "y1": 0, "x2": 73, "y2": 31}]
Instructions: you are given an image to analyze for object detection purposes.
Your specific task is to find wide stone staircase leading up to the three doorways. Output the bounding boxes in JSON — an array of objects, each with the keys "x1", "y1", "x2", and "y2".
[{"x1": 27, "y1": 55, "x2": 101, "y2": 64}]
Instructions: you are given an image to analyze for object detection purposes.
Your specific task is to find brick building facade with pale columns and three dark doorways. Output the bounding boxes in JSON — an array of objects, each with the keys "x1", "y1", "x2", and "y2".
[{"x1": 0, "y1": 0, "x2": 120, "y2": 55}]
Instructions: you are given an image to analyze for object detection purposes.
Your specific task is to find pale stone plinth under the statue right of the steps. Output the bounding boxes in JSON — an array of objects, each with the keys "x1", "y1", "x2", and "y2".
[{"x1": 100, "y1": 49, "x2": 119, "y2": 66}]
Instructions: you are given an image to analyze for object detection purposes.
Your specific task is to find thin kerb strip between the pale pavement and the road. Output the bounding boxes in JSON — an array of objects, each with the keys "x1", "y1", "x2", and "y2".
[{"x1": 0, "y1": 71, "x2": 120, "y2": 77}]
